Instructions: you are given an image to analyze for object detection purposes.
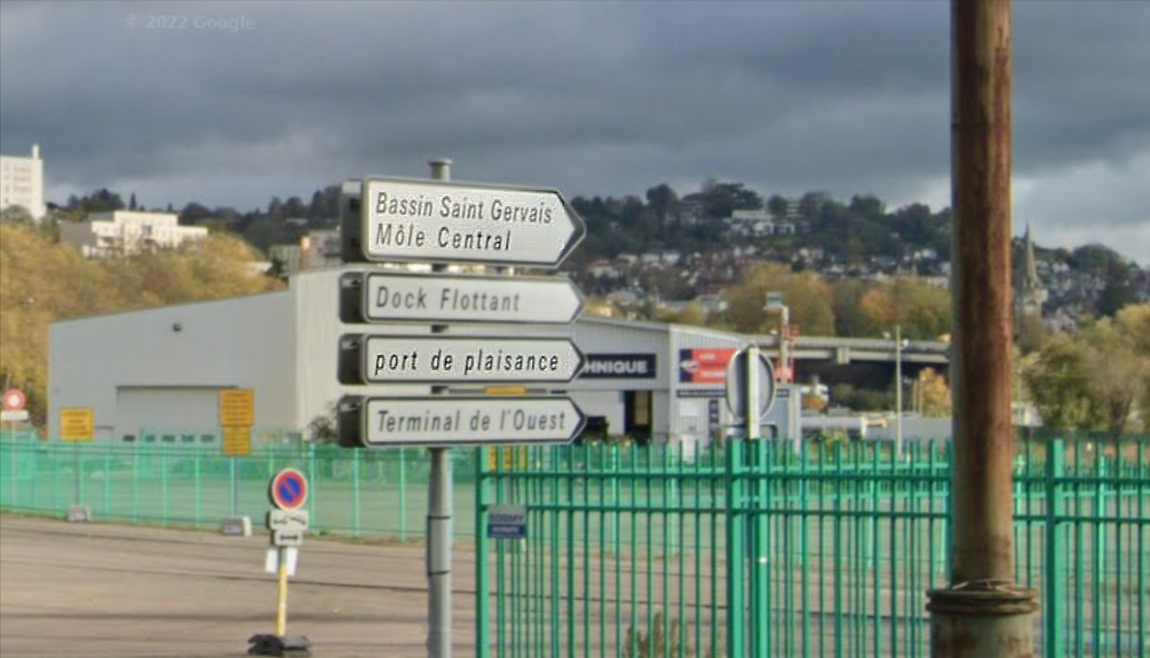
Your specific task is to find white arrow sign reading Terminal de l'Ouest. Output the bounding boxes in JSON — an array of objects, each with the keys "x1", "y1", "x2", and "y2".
[{"x1": 360, "y1": 397, "x2": 587, "y2": 446}]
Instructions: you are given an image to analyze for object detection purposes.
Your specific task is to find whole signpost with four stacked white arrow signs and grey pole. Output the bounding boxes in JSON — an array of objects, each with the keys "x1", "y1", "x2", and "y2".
[{"x1": 338, "y1": 161, "x2": 587, "y2": 658}]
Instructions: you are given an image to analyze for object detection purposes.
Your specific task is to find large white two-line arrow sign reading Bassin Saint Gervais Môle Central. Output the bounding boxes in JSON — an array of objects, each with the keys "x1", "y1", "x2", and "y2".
[{"x1": 361, "y1": 178, "x2": 587, "y2": 267}]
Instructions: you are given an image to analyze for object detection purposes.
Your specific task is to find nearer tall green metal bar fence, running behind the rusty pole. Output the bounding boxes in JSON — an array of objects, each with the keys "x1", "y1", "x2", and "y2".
[{"x1": 476, "y1": 439, "x2": 1150, "y2": 658}]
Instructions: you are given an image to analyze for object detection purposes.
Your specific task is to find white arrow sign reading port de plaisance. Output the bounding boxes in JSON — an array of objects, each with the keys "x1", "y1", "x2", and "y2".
[{"x1": 342, "y1": 336, "x2": 583, "y2": 384}]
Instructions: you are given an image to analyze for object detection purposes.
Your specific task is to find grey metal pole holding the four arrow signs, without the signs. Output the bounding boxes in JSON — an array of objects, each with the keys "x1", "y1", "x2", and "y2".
[{"x1": 427, "y1": 159, "x2": 452, "y2": 658}]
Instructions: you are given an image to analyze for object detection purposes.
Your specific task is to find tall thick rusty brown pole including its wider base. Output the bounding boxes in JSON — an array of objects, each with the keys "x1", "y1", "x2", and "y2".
[{"x1": 927, "y1": 0, "x2": 1038, "y2": 658}]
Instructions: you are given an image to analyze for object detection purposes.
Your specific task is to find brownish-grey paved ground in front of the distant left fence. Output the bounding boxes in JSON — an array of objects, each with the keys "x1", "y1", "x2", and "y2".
[{"x1": 0, "y1": 514, "x2": 475, "y2": 658}]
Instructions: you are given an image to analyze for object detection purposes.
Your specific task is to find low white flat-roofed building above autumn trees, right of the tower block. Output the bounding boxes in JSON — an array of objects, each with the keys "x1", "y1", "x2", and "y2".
[{"x1": 60, "y1": 211, "x2": 208, "y2": 258}]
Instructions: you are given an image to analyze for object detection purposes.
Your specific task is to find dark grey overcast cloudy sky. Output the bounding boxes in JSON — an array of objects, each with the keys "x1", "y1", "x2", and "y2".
[{"x1": 0, "y1": 0, "x2": 1150, "y2": 265}]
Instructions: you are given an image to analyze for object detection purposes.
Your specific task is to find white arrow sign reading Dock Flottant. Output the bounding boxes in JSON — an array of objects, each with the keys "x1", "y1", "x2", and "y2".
[{"x1": 351, "y1": 273, "x2": 584, "y2": 324}]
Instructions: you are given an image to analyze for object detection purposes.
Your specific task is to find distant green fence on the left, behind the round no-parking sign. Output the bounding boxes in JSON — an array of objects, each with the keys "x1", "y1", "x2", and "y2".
[{"x1": 0, "y1": 433, "x2": 475, "y2": 541}]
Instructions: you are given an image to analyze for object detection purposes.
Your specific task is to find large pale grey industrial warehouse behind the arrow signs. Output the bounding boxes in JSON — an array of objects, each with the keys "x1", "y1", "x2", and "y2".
[{"x1": 48, "y1": 269, "x2": 800, "y2": 449}]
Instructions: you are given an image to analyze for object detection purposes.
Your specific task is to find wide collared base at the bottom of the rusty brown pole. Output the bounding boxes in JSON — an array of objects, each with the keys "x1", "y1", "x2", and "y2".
[{"x1": 927, "y1": 580, "x2": 1038, "y2": 658}]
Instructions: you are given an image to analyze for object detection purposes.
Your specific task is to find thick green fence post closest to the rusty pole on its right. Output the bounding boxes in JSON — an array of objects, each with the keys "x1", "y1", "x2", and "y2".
[{"x1": 1043, "y1": 438, "x2": 1062, "y2": 658}]
